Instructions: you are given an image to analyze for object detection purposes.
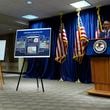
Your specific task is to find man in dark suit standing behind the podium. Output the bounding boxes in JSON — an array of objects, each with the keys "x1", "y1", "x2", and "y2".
[{"x1": 99, "y1": 20, "x2": 110, "y2": 38}]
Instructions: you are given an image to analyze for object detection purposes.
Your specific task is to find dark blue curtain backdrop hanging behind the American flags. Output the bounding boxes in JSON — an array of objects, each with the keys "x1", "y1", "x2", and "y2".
[{"x1": 26, "y1": 5, "x2": 108, "y2": 83}]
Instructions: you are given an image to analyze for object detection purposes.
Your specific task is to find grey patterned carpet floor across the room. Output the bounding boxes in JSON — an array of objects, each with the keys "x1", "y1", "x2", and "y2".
[{"x1": 0, "y1": 74, "x2": 110, "y2": 110}]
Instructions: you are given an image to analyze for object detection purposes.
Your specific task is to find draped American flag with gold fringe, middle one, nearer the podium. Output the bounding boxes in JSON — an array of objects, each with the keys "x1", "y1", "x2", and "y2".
[{"x1": 73, "y1": 15, "x2": 88, "y2": 63}]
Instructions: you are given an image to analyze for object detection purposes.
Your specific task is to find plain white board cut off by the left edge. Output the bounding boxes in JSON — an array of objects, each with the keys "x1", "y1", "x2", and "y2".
[{"x1": 0, "y1": 40, "x2": 6, "y2": 61}]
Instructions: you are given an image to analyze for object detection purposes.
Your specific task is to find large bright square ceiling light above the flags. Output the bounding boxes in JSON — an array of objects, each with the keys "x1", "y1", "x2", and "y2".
[{"x1": 70, "y1": 0, "x2": 91, "y2": 8}]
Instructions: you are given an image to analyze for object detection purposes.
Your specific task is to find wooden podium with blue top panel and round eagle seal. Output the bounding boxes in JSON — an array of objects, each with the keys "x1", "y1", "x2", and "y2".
[{"x1": 86, "y1": 39, "x2": 110, "y2": 96}]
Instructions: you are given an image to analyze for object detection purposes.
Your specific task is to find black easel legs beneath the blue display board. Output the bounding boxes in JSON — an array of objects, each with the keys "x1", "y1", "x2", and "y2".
[{"x1": 16, "y1": 59, "x2": 44, "y2": 92}]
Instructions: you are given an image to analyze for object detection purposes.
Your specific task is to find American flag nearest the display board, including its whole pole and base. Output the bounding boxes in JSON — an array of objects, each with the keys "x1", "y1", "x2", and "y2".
[{"x1": 55, "y1": 13, "x2": 68, "y2": 80}]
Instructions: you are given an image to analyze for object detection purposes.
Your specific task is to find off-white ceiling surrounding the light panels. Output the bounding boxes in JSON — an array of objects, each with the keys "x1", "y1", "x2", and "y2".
[{"x1": 0, "y1": 0, "x2": 110, "y2": 34}]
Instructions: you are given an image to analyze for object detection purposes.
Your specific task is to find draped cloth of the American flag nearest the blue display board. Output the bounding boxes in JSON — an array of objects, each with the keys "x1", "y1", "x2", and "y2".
[{"x1": 55, "y1": 23, "x2": 68, "y2": 63}]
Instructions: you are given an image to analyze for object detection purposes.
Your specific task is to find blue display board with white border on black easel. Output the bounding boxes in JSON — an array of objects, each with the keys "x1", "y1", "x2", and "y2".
[{"x1": 14, "y1": 28, "x2": 51, "y2": 58}]
